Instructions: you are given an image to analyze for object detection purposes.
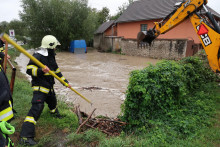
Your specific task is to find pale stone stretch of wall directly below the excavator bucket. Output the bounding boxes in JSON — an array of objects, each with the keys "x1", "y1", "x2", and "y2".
[{"x1": 121, "y1": 39, "x2": 187, "y2": 59}]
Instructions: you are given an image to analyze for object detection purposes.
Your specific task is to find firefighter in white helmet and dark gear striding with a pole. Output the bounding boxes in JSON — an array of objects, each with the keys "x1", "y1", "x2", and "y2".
[{"x1": 20, "y1": 35, "x2": 71, "y2": 145}]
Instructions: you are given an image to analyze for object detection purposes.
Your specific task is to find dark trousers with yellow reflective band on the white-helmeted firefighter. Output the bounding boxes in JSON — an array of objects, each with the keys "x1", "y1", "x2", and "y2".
[{"x1": 20, "y1": 89, "x2": 57, "y2": 138}]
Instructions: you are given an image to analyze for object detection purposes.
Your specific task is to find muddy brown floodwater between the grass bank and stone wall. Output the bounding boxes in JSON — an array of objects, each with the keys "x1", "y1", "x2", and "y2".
[{"x1": 16, "y1": 49, "x2": 158, "y2": 117}]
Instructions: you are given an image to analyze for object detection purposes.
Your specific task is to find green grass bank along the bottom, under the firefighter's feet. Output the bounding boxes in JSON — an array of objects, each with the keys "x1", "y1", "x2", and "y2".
[{"x1": 3, "y1": 47, "x2": 220, "y2": 147}]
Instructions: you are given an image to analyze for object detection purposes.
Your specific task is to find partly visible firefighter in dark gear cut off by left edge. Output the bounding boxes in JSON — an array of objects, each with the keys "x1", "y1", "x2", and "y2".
[{"x1": 0, "y1": 39, "x2": 14, "y2": 146}]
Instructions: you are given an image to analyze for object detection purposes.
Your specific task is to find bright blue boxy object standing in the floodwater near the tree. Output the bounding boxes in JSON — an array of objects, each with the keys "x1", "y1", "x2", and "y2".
[{"x1": 70, "y1": 40, "x2": 87, "y2": 53}]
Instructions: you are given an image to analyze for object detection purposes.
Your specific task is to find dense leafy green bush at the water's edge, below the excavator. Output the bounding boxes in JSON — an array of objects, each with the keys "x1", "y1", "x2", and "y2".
[{"x1": 122, "y1": 57, "x2": 216, "y2": 136}]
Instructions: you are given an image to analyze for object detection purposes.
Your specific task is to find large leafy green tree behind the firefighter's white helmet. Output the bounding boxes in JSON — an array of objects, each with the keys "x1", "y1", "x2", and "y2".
[{"x1": 20, "y1": 0, "x2": 90, "y2": 50}]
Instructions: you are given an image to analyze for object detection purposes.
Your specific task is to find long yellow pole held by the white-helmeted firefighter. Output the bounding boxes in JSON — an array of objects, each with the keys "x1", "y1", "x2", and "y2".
[{"x1": 0, "y1": 33, "x2": 92, "y2": 104}]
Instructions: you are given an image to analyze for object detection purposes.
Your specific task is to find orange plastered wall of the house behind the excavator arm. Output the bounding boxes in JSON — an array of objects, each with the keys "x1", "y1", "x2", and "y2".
[{"x1": 117, "y1": 19, "x2": 200, "y2": 43}]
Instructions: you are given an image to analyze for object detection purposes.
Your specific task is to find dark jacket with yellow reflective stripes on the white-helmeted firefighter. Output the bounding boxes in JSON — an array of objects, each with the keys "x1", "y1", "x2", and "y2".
[{"x1": 26, "y1": 49, "x2": 68, "y2": 93}]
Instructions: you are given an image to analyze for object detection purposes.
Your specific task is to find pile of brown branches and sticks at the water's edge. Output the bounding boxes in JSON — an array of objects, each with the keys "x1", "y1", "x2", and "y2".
[{"x1": 75, "y1": 106, "x2": 126, "y2": 136}]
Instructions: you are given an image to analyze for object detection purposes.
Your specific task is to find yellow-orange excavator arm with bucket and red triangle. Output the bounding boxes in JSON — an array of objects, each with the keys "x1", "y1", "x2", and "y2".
[{"x1": 141, "y1": 0, "x2": 220, "y2": 72}]
